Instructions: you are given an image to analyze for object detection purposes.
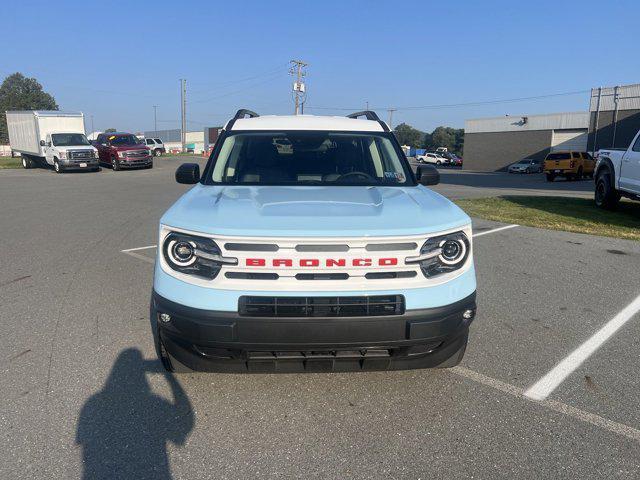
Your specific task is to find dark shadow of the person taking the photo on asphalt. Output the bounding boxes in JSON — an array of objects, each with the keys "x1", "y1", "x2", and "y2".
[{"x1": 76, "y1": 348, "x2": 194, "y2": 480}]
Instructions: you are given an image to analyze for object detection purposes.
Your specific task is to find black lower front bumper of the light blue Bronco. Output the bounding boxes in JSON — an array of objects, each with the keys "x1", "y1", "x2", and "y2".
[{"x1": 151, "y1": 292, "x2": 476, "y2": 372}]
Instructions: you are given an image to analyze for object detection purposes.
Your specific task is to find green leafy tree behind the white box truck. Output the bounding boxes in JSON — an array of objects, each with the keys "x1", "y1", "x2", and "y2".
[{"x1": 0, "y1": 72, "x2": 58, "y2": 144}]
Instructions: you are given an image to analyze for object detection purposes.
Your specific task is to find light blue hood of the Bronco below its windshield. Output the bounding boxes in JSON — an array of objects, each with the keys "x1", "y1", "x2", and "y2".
[{"x1": 160, "y1": 184, "x2": 471, "y2": 237}]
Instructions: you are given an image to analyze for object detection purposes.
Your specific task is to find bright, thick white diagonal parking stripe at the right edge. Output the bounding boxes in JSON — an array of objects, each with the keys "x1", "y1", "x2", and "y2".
[{"x1": 524, "y1": 295, "x2": 640, "y2": 400}]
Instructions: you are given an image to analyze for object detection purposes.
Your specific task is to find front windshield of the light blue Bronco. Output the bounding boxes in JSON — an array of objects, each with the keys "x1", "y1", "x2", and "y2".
[{"x1": 205, "y1": 131, "x2": 415, "y2": 186}]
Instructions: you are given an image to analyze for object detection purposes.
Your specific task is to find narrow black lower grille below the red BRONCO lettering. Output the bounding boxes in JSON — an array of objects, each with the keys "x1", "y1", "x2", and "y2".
[{"x1": 238, "y1": 295, "x2": 405, "y2": 317}]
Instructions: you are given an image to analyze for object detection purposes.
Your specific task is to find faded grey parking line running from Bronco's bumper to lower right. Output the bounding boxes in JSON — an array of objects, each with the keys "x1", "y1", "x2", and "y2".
[{"x1": 448, "y1": 366, "x2": 640, "y2": 442}]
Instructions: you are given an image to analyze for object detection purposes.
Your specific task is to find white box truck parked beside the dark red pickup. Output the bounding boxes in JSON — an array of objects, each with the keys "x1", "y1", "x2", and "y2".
[{"x1": 6, "y1": 110, "x2": 100, "y2": 173}]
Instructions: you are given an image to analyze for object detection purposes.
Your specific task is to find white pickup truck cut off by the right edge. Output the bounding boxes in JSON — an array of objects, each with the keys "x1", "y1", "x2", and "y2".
[{"x1": 594, "y1": 131, "x2": 640, "y2": 209}]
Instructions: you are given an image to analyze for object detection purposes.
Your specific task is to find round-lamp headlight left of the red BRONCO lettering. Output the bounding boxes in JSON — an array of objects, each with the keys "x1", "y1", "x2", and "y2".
[{"x1": 162, "y1": 232, "x2": 238, "y2": 280}]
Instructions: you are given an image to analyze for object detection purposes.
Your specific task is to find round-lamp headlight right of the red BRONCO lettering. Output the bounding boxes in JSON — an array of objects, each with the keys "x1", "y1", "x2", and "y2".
[{"x1": 405, "y1": 232, "x2": 471, "y2": 278}]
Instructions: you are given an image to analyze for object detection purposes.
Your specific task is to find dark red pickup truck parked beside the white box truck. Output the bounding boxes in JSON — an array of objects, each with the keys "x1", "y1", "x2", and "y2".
[{"x1": 94, "y1": 132, "x2": 153, "y2": 171}]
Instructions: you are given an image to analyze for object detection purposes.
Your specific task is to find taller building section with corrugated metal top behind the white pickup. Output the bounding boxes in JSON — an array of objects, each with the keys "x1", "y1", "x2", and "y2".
[{"x1": 589, "y1": 84, "x2": 640, "y2": 152}]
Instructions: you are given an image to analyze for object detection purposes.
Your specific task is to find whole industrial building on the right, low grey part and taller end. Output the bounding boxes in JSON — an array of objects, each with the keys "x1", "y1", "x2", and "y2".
[{"x1": 463, "y1": 84, "x2": 640, "y2": 172}]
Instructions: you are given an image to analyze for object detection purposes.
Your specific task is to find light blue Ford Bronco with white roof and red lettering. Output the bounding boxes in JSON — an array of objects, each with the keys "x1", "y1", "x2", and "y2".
[{"x1": 150, "y1": 110, "x2": 476, "y2": 372}]
